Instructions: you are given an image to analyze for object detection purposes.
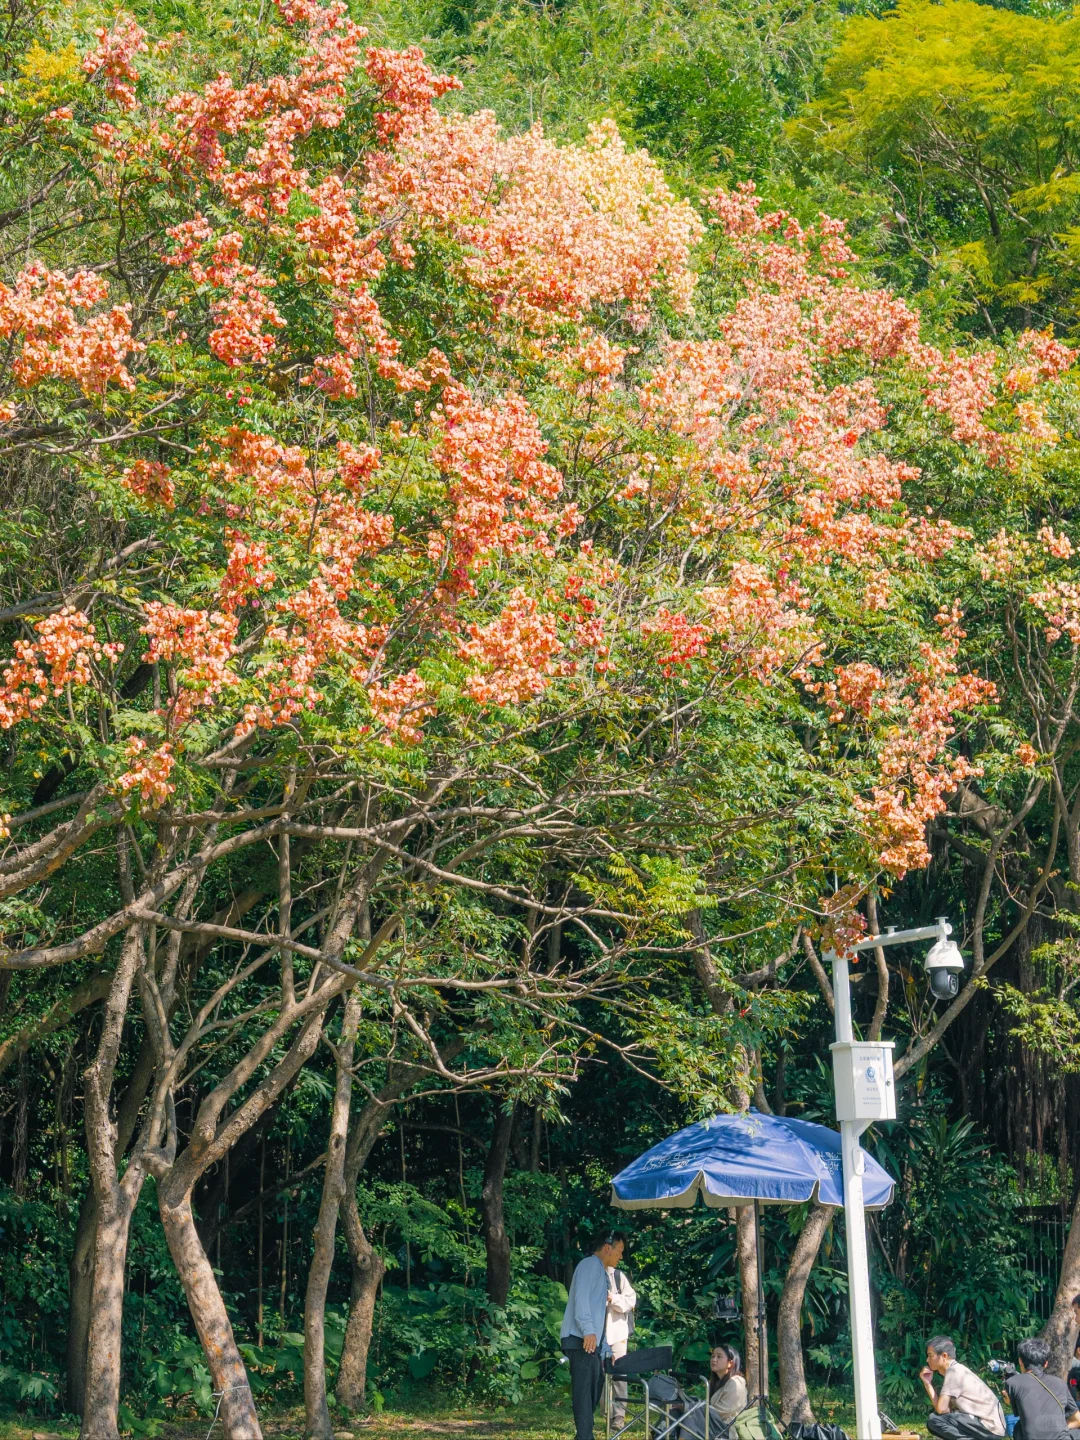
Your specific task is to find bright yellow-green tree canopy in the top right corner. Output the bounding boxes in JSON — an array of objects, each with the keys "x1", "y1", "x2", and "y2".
[{"x1": 792, "y1": 0, "x2": 1080, "y2": 325}]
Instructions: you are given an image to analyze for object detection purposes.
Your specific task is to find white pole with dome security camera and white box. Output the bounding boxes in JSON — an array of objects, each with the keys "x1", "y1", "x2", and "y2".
[{"x1": 825, "y1": 920, "x2": 963, "y2": 1440}]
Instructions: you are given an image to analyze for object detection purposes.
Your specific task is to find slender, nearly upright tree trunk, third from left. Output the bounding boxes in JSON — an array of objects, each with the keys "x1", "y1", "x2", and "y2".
[{"x1": 304, "y1": 994, "x2": 360, "y2": 1440}]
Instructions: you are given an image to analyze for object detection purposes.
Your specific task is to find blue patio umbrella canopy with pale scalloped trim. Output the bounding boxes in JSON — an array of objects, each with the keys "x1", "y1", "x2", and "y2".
[{"x1": 612, "y1": 1110, "x2": 894, "y2": 1210}]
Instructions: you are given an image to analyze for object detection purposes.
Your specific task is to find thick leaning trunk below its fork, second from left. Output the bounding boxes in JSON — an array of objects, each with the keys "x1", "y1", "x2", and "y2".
[{"x1": 157, "y1": 1184, "x2": 262, "y2": 1440}]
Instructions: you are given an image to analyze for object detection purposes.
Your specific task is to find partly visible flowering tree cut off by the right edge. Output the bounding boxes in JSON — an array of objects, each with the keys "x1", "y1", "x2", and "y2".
[{"x1": 897, "y1": 504, "x2": 1080, "y2": 1374}]
